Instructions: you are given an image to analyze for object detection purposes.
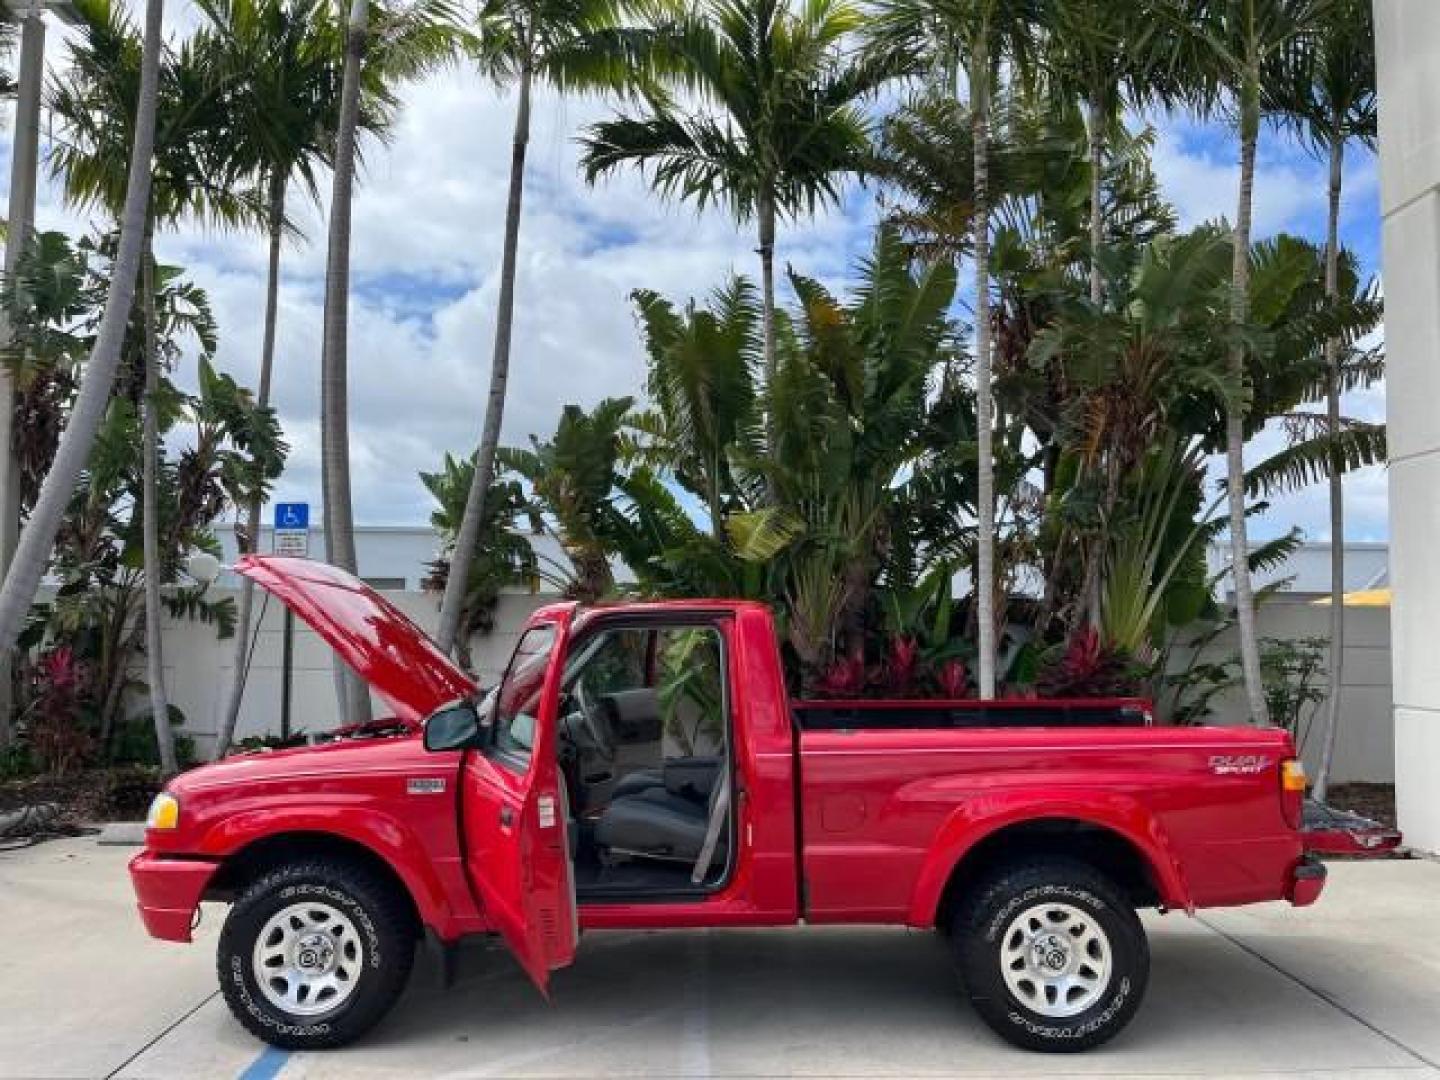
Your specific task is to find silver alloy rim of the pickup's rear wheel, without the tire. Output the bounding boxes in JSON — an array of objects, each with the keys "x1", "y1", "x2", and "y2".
[{"x1": 999, "y1": 901, "x2": 1112, "y2": 1020}]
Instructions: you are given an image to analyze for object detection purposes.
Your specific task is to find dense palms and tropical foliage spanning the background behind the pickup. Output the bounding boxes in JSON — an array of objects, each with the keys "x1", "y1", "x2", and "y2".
[{"x1": 0, "y1": 0, "x2": 1385, "y2": 769}]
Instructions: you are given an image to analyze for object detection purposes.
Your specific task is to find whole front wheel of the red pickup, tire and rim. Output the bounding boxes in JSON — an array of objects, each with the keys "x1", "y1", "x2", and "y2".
[{"x1": 217, "y1": 860, "x2": 415, "y2": 1050}]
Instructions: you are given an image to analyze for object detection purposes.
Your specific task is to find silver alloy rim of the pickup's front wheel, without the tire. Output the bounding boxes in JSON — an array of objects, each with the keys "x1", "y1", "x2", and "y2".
[{"x1": 251, "y1": 903, "x2": 364, "y2": 1017}]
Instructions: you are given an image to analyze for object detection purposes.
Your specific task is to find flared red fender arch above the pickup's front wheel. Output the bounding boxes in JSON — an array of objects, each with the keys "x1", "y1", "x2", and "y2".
[{"x1": 202, "y1": 804, "x2": 456, "y2": 937}]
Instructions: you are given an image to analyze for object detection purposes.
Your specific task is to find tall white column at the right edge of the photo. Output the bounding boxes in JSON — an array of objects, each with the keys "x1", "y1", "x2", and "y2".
[{"x1": 1375, "y1": 0, "x2": 1440, "y2": 851}]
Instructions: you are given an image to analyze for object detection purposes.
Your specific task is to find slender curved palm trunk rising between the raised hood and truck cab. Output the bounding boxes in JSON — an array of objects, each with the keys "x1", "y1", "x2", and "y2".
[{"x1": 436, "y1": 63, "x2": 533, "y2": 654}]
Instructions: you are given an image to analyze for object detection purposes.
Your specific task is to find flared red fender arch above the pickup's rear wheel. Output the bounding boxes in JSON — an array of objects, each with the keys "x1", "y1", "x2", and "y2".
[{"x1": 907, "y1": 788, "x2": 1195, "y2": 927}]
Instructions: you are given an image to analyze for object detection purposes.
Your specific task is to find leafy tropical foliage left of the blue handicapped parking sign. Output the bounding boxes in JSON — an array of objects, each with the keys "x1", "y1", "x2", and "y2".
[{"x1": 3, "y1": 232, "x2": 285, "y2": 769}]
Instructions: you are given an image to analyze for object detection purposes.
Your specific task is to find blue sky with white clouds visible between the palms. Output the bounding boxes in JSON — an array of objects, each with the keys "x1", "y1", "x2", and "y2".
[{"x1": 0, "y1": 18, "x2": 1387, "y2": 552}]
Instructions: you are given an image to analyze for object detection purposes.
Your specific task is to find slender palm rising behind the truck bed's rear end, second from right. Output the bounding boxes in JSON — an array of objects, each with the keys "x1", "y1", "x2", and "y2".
[{"x1": 1152, "y1": 0, "x2": 1332, "y2": 724}]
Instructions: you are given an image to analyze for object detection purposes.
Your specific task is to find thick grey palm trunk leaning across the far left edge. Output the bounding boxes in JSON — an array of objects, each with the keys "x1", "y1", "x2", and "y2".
[{"x1": 0, "y1": 0, "x2": 164, "y2": 652}]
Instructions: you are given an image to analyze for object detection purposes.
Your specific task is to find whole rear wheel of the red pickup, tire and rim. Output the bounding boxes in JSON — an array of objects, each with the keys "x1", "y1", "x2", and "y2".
[{"x1": 952, "y1": 858, "x2": 1151, "y2": 1053}]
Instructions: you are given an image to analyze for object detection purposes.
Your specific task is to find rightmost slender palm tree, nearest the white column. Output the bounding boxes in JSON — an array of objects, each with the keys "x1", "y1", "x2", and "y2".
[{"x1": 1266, "y1": 0, "x2": 1377, "y2": 802}]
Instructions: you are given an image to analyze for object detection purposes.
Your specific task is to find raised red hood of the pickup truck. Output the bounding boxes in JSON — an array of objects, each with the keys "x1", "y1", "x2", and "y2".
[{"x1": 235, "y1": 554, "x2": 477, "y2": 723}]
